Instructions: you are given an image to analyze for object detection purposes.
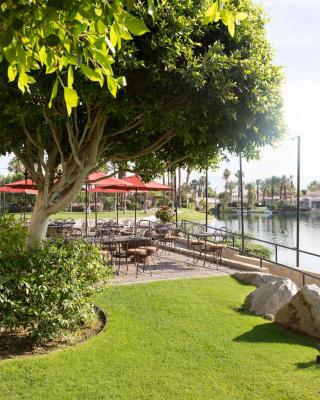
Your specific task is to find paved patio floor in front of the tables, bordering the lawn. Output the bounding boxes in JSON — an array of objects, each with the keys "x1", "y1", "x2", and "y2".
[{"x1": 112, "y1": 250, "x2": 235, "y2": 285}]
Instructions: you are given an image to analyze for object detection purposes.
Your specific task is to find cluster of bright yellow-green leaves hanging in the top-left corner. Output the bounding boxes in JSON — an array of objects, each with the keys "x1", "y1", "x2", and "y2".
[{"x1": 0, "y1": 0, "x2": 154, "y2": 115}]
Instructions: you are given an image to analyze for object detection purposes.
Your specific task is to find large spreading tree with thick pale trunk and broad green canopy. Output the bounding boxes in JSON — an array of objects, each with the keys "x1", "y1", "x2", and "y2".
[{"x1": 0, "y1": 0, "x2": 282, "y2": 245}]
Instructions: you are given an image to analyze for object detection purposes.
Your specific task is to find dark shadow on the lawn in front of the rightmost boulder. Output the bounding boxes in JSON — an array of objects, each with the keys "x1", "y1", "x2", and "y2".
[{"x1": 233, "y1": 323, "x2": 317, "y2": 348}]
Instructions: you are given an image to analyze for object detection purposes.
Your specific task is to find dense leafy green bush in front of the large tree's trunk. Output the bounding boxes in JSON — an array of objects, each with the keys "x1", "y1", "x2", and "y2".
[{"x1": 0, "y1": 218, "x2": 110, "y2": 343}]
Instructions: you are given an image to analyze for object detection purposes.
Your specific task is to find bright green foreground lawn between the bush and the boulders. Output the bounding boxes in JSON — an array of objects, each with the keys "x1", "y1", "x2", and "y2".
[{"x1": 0, "y1": 277, "x2": 320, "y2": 400}]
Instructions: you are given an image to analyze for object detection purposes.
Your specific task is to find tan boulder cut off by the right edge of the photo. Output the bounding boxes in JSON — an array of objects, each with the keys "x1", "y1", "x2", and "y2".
[{"x1": 275, "y1": 285, "x2": 320, "y2": 338}]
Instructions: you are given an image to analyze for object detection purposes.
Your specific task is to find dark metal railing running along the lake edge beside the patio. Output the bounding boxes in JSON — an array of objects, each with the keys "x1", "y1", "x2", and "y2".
[{"x1": 181, "y1": 220, "x2": 320, "y2": 285}]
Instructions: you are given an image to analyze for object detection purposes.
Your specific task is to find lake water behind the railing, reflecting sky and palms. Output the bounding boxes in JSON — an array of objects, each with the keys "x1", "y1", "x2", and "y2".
[{"x1": 212, "y1": 214, "x2": 320, "y2": 272}]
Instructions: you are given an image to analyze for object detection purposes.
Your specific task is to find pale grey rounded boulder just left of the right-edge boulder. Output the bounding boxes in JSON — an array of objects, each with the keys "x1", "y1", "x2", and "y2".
[{"x1": 245, "y1": 278, "x2": 299, "y2": 315}]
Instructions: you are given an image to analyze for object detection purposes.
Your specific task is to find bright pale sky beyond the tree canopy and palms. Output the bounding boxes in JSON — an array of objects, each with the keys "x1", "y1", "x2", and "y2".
[{"x1": 0, "y1": 0, "x2": 320, "y2": 191}]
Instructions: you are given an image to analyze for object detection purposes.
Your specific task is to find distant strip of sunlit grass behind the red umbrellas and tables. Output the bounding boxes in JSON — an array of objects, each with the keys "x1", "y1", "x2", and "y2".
[{"x1": 14, "y1": 208, "x2": 210, "y2": 221}]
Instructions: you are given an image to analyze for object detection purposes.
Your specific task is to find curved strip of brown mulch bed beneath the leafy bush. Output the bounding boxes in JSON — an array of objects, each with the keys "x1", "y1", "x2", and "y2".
[{"x1": 0, "y1": 304, "x2": 108, "y2": 362}]
